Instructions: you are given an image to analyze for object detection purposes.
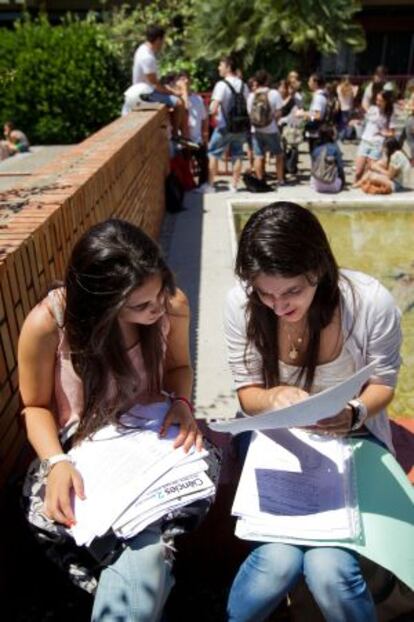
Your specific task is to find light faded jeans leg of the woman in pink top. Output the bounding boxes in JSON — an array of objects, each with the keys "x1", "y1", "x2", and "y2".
[{"x1": 92, "y1": 524, "x2": 174, "y2": 622}]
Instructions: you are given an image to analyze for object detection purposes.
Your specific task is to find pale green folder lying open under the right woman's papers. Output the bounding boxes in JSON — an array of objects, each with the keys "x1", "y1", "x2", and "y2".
[{"x1": 236, "y1": 439, "x2": 414, "y2": 589}]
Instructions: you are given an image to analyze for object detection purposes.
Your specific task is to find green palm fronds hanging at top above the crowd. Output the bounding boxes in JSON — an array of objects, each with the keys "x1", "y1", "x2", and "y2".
[{"x1": 192, "y1": 0, "x2": 364, "y2": 73}]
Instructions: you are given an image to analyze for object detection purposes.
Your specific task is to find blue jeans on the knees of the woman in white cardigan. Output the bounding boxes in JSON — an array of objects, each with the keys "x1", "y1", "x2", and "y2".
[{"x1": 227, "y1": 543, "x2": 377, "y2": 622}]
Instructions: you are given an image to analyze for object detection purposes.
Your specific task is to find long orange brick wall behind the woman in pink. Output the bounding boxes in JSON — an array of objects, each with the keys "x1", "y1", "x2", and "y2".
[{"x1": 0, "y1": 109, "x2": 168, "y2": 487}]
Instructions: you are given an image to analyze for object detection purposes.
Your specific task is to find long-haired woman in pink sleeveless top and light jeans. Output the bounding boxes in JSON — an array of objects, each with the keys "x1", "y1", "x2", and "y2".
[{"x1": 19, "y1": 220, "x2": 202, "y2": 622}]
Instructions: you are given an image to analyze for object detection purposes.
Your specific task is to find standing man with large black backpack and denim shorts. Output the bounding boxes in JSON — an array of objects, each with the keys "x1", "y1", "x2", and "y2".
[{"x1": 208, "y1": 56, "x2": 250, "y2": 192}]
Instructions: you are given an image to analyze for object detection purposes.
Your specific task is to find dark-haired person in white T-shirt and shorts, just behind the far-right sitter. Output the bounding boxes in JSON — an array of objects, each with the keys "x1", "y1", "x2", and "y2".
[{"x1": 355, "y1": 91, "x2": 395, "y2": 182}]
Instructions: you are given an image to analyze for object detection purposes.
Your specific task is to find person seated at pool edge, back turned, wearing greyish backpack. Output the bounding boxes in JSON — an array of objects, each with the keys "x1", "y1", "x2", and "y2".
[{"x1": 310, "y1": 123, "x2": 345, "y2": 192}]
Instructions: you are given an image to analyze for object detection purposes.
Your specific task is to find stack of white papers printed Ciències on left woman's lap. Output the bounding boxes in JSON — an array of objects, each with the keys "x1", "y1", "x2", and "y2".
[{"x1": 70, "y1": 402, "x2": 215, "y2": 545}]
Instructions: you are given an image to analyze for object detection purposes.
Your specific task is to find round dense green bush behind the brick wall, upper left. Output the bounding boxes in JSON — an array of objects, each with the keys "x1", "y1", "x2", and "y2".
[{"x1": 0, "y1": 16, "x2": 122, "y2": 143}]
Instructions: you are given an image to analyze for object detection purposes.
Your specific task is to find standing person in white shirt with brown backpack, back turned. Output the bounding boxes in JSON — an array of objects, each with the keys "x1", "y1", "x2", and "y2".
[{"x1": 247, "y1": 69, "x2": 284, "y2": 185}]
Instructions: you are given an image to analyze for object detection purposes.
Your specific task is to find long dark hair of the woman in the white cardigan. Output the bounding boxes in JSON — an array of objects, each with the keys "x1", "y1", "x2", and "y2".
[{"x1": 236, "y1": 201, "x2": 339, "y2": 391}]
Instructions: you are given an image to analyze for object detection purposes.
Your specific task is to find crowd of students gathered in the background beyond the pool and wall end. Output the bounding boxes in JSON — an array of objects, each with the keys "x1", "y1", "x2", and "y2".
[{"x1": 123, "y1": 26, "x2": 414, "y2": 193}]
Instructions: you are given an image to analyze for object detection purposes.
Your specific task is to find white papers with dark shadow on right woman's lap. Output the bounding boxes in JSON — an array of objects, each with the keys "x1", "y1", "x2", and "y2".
[{"x1": 232, "y1": 429, "x2": 360, "y2": 542}]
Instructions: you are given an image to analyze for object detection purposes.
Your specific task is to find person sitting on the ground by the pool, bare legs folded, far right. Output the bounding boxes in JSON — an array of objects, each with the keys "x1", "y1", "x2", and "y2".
[{"x1": 356, "y1": 136, "x2": 411, "y2": 194}]
